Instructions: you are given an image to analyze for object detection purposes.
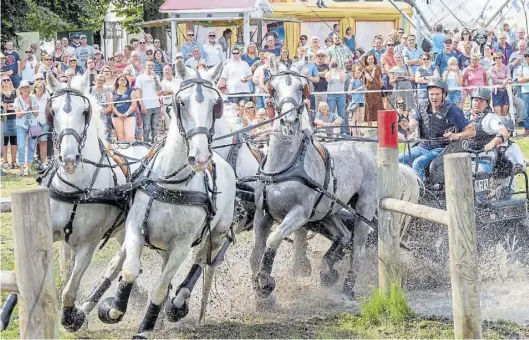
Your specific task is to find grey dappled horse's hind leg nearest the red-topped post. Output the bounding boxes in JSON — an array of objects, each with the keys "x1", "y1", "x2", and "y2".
[{"x1": 343, "y1": 193, "x2": 376, "y2": 299}]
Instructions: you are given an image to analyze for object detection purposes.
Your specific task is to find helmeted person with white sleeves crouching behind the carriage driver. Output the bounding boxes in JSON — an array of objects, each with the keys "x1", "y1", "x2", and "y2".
[{"x1": 466, "y1": 88, "x2": 525, "y2": 173}]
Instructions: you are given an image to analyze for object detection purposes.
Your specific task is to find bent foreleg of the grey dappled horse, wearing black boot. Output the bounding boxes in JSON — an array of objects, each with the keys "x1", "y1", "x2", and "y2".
[{"x1": 254, "y1": 206, "x2": 308, "y2": 298}]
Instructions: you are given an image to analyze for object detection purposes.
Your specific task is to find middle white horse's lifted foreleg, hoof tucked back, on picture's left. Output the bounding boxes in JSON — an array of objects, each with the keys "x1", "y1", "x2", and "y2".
[{"x1": 98, "y1": 221, "x2": 145, "y2": 324}]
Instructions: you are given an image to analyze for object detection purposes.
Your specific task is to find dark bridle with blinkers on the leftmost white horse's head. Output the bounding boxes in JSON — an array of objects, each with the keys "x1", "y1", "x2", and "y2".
[{"x1": 45, "y1": 88, "x2": 92, "y2": 154}]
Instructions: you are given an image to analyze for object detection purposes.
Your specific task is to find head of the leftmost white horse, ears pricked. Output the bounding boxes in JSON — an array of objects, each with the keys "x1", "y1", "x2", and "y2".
[{"x1": 45, "y1": 71, "x2": 92, "y2": 174}]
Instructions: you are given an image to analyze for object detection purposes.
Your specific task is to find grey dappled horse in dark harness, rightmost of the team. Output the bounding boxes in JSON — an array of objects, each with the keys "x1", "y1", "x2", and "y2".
[{"x1": 251, "y1": 60, "x2": 377, "y2": 303}]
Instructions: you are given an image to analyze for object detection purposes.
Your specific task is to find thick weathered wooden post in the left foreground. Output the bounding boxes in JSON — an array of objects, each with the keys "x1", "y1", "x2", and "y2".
[{"x1": 11, "y1": 188, "x2": 59, "y2": 339}]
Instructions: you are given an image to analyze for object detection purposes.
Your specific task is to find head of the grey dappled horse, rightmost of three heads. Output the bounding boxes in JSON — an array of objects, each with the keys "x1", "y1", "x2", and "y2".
[{"x1": 268, "y1": 58, "x2": 310, "y2": 135}]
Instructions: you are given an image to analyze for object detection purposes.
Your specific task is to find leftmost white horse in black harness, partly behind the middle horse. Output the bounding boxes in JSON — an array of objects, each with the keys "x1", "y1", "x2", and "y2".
[{"x1": 41, "y1": 72, "x2": 148, "y2": 332}]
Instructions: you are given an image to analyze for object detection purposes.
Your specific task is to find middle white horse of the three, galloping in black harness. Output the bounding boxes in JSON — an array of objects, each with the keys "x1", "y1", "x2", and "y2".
[{"x1": 99, "y1": 61, "x2": 235, "y2": 338}]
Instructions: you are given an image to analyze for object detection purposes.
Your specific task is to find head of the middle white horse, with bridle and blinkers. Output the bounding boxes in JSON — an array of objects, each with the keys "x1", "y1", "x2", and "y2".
[{"x1": 173, "y1": 60, "x2": 223, "y2": 171}]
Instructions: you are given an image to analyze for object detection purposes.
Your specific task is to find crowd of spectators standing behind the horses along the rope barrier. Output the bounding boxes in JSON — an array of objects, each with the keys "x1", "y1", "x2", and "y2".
[{"x1": 0, "y1": 21, "x2": 529, "y2": 175}]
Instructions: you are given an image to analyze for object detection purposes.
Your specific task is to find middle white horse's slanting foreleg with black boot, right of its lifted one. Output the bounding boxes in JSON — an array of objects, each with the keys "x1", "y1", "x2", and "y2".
[{"x1": 133, "y1": 240, "x2": 191, "y2": 339}]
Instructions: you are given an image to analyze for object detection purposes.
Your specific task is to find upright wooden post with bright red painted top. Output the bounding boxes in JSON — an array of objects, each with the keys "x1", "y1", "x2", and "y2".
[{"x1": 377, "y1": 111, "x2": 402, "y2": 293}]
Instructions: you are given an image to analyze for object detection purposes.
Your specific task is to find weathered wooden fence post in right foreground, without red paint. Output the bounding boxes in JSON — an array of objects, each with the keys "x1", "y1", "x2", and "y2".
[{"x1": 444, "y1": 153, "x2": 481, "y2": 339}]
